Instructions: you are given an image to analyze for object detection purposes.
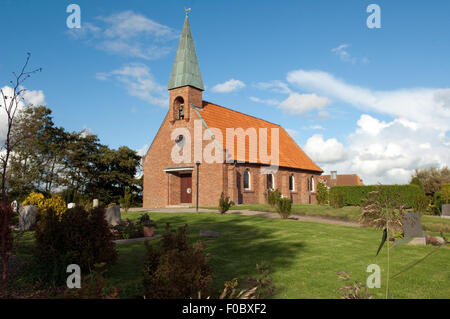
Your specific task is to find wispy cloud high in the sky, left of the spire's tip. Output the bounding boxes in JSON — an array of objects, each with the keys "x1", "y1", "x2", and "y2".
[{"x1": 68, "y1": 11, "x2": 179, "y2": 60}]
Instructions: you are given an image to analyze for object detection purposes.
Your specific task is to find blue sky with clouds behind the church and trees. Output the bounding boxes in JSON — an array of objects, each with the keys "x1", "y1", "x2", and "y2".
[{"x1": 0, "y1": 0, "x2": 450, "y2": 183}]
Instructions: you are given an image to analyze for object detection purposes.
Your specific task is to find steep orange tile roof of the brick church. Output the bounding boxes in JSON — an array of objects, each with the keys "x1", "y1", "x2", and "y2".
[{"x1": 194, "y1": 101, "x2": 323, "y2": 172}]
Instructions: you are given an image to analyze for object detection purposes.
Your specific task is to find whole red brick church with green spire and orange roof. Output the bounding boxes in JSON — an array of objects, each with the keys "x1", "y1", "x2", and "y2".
[{"x1": 143, "y1": 15, "x2": 323, "y2": 208}]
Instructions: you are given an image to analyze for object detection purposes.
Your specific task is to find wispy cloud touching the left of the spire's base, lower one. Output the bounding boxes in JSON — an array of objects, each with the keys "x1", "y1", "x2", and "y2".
[{"x1": 96, "y1": 63, "x2": 168, "y2": 107}]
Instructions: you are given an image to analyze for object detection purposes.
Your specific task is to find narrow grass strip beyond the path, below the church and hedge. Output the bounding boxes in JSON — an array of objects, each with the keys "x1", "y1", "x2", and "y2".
[{"x1": 203, "y1": 204, "x2": 450, "y2": 236}]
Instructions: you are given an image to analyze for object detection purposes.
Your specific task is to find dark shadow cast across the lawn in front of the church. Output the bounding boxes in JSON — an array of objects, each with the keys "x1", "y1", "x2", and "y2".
[{"x1": 109, "y1": 213, "x2": 304, "y2": 297}]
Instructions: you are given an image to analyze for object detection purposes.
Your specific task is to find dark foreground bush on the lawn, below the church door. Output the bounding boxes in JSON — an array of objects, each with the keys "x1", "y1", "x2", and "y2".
[{"x1": 143, "y1": 224, "x2": 213, "y2": 299}]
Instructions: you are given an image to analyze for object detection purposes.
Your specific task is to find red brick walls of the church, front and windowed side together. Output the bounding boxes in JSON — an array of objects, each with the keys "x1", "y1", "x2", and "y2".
[{"x1": 143, "y1": 87, "x2": 319, "y2": 208}]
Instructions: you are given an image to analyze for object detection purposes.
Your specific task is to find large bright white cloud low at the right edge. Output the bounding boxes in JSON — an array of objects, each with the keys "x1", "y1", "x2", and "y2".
[{"x1": 316, "y1": 114, "x2": 450, "y2": 184}]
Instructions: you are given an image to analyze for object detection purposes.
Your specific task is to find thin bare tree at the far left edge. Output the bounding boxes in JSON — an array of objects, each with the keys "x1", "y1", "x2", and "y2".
[{"x1": 0, "y1": 53, "x2": 42, "y2": 284}]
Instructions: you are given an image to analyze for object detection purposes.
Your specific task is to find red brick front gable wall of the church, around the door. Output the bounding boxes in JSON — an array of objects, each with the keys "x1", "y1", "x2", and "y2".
[{"x1": 143, "y1": 87, "x2": 226, "y2": 208}]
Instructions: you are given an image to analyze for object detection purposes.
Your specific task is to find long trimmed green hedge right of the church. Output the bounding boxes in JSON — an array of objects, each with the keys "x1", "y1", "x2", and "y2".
[{"x1": 330, "y1": 185, "x2": 423, "y2": 207}]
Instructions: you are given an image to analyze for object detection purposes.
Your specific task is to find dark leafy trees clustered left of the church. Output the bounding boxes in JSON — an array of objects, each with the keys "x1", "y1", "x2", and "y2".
[{"x1": 9, "y1": 106, "x2": 142, "y2": 203}]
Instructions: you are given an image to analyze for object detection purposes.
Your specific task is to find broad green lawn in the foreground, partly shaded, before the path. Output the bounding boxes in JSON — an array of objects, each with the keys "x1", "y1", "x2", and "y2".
[{"x1": 107, "y1": 212, "x2": 450, "y2": 298}]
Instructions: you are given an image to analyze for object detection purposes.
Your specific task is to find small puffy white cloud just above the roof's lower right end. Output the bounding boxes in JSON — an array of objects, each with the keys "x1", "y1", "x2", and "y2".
[{"x1": 304, "y1": 134, "x2": 346, "y2": 164}]
